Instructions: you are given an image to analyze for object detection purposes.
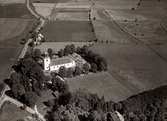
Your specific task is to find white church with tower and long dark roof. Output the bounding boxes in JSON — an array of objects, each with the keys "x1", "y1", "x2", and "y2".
[{"x1": 44, "y1": 56, "x2": 76, "y2": 72}]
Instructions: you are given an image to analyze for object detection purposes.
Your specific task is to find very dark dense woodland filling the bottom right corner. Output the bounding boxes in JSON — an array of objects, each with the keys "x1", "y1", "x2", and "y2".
[{"x1": 122, "y1": 86, "x2": 167, "y2": 121}]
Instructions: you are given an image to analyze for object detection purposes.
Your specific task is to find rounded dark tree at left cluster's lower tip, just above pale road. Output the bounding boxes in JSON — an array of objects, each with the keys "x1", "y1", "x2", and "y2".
[{"x1": 24, "y1": 91, "x2": 38, "y2": 107}]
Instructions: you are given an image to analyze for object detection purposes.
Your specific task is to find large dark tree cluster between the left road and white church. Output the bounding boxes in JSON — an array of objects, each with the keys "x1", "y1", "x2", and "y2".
[{"x1": 7, "y1": 50, "x2": 45, "y2": 106}]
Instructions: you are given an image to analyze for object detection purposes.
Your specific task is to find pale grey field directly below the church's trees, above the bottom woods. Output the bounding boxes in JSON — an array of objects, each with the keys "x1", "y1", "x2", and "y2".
[{"x1": 67, "y1": 72, "x2": 133, "y2": 102}]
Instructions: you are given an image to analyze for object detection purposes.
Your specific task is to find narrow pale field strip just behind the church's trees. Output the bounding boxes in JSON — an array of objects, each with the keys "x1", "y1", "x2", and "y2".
[{"x1": 35, "y1": 42, "x2": 92, "y2": 53}]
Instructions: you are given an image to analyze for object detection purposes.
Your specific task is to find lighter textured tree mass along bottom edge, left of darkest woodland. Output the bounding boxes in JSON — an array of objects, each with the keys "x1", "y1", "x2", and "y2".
[{"x1": 46, "y1": 87, "x2": 121, "y2": 121}]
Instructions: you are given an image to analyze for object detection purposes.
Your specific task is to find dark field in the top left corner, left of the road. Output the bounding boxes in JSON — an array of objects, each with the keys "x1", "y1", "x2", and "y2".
[{"x1": 0, "y1": 3, "x2": 33, "y2": 18}]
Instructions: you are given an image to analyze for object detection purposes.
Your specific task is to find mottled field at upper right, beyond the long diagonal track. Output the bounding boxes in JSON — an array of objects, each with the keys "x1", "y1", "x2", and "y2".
[{"x1": 105, "y1": 0, "x2": 167, "y2": 44}]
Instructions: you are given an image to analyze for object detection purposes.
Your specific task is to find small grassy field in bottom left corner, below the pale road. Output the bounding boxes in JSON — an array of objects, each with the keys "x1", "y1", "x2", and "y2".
[{"x1": 0, "y1": 102, "x2": 30, "y2": 121}]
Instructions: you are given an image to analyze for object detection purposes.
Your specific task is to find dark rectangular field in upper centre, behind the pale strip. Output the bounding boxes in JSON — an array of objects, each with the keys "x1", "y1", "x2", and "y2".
[{"x1": 43, "y1": 21, "x2": 95, "y2": 42}]
